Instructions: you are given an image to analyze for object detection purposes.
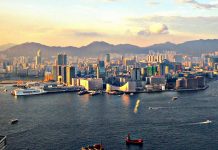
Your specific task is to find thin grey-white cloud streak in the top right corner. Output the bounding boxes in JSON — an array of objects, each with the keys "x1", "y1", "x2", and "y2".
[{"x1": 176, "y1": 0, "x2": 218, "y2": 9}]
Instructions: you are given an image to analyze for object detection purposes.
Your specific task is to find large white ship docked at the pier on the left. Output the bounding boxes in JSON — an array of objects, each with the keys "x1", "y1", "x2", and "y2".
[{"x1": 11, "y1": 87, "x2": 47, "y2": 96}]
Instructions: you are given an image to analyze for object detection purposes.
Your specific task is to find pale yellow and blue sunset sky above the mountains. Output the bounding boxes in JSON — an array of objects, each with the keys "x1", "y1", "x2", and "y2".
[{"x1": 0, "y1": 0, "x2": 218, "y2": 47}]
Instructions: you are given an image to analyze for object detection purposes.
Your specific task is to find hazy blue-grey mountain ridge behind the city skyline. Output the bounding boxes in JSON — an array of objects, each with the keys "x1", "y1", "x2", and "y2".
[{"x1": 0, "y1": 39, "x2": 218, "y2": 57}]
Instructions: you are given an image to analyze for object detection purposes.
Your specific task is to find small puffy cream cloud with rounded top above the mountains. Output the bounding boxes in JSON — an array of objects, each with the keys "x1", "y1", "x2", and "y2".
[{"x1": 138, "y1": 23, "x2": 169, "y2": 36}]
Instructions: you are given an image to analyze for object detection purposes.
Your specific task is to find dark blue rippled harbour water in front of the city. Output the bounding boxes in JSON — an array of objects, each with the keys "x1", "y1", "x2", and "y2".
[{"x1": 0, "y1": 81, "x2": 218, "y2": 150}]
